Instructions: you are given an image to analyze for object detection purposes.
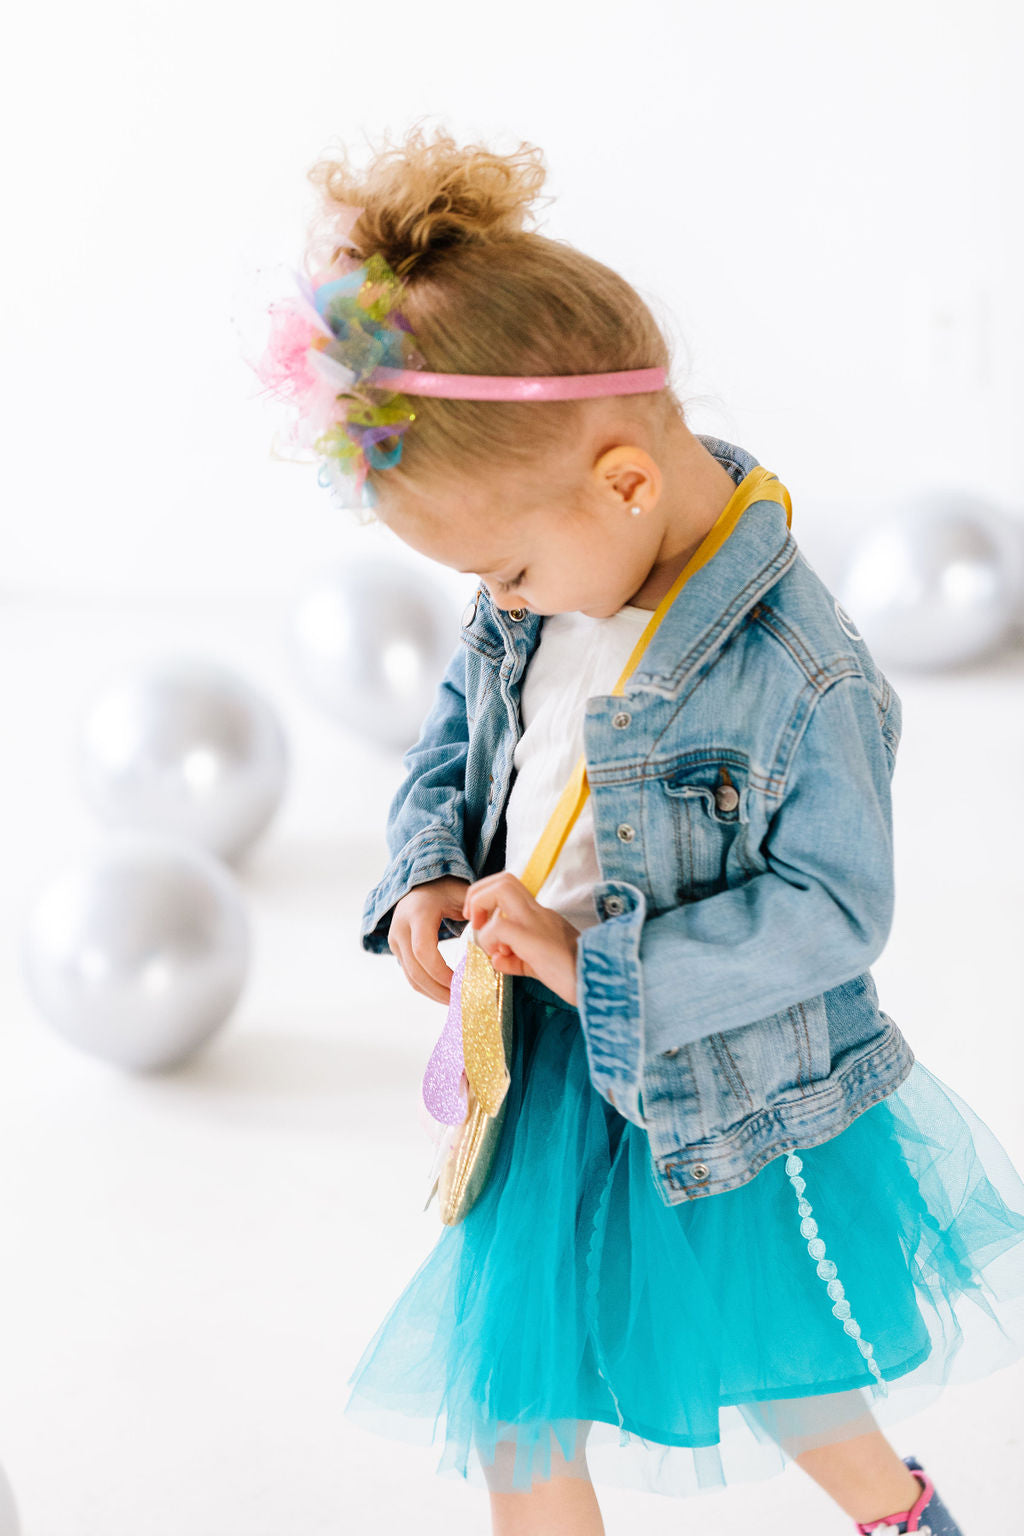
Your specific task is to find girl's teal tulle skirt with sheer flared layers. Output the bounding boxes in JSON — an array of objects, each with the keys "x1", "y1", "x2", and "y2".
[{"x1": 344, "y1": 978, "x2": 1024, "y2": 1495}]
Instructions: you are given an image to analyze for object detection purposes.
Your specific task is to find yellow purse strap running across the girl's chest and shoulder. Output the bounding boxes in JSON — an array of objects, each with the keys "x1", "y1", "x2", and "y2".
[{"x1": 520, "y1": 464, "x2": 792, "y2": 897}]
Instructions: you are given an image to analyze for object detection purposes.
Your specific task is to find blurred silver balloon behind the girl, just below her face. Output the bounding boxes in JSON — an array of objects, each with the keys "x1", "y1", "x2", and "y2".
[{"x1": 287, "y1": 558, "x2": 465, "y2": 751}]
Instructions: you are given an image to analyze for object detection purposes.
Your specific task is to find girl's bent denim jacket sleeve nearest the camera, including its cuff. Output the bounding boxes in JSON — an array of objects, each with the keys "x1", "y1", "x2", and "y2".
[{"x1": 576, "y1": 677, "x2": 894, "y2": 1123}]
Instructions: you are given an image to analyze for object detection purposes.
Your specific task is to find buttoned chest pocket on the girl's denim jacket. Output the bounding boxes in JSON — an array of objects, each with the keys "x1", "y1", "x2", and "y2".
[{"x1": 660, "y1": 759, "x2": 757, "y2": 902}]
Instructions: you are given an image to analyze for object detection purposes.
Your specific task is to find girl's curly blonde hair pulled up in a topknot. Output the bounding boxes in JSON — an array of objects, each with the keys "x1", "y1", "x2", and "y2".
[{"x1": 306, "y1": 124, "x2": 683, "y2": 513}]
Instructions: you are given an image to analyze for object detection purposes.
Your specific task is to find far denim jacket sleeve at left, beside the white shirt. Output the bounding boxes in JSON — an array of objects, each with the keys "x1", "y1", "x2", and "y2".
[{"x1": 362, "y1": 639, "x2": 476, "y2": 954}]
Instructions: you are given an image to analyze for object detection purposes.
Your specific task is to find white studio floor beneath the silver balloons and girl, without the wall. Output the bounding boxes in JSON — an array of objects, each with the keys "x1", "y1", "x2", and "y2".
[{"x1": 0, "y1": 589, "x2": 1024, "y2": 1536}]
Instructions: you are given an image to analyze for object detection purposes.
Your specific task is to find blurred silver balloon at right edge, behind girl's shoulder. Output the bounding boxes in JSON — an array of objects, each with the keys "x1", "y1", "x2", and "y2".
[{"x1": 837, "y1": 498, "x2": 1018, "y2": 670}]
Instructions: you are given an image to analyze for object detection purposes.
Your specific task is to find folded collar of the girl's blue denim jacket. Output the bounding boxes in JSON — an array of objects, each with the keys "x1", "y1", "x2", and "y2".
[{"x1": 464, "y1": 433, "x2": 797, "y2": 696}]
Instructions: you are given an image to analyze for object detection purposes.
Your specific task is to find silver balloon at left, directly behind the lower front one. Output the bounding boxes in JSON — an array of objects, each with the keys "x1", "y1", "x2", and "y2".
[{"x1": 78, "y1": 657, "x2": 287, "y2": 860}]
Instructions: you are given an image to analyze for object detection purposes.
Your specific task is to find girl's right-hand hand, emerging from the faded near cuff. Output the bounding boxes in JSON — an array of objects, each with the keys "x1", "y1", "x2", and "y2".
[{"x1": 462, "y1": 869, "x2": 579, "y2": 1008}]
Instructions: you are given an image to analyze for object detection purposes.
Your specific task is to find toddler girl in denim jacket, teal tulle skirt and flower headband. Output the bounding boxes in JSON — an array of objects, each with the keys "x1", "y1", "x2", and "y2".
[{"x1": 251, "y1": 129, "x2": 1024, "y2": 1536}]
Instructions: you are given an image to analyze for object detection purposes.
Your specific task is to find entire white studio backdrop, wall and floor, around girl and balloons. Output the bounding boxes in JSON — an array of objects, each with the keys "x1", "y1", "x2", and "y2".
[{"x1": 0, "y1": 0, "x2": 1024, "y2": 1536}]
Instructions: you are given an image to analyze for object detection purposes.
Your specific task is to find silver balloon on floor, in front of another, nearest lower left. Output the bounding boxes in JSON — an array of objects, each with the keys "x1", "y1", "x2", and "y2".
[{"x1": 23, "y1": 831, "x2": 250, "y2": 1071}]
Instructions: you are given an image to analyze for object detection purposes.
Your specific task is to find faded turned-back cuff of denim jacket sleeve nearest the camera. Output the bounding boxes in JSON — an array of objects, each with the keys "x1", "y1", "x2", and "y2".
[{"x1": 576, "y1": 880, "x2": 646, "y2": 1126}]
